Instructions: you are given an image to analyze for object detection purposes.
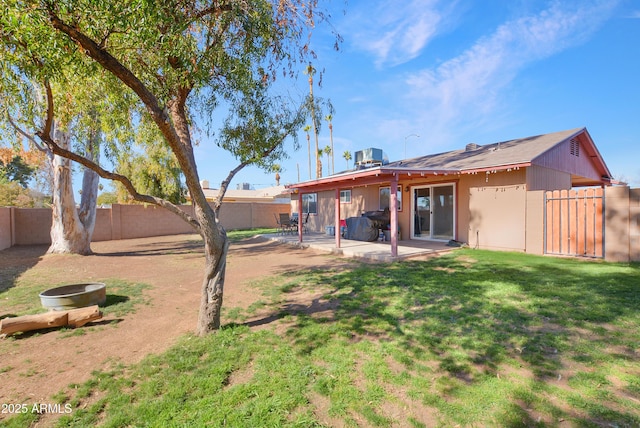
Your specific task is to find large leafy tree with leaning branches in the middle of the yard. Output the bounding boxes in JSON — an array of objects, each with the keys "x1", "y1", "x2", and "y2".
[{"x1": 0, "y1": 0, "x2": 336, "y2": 334}]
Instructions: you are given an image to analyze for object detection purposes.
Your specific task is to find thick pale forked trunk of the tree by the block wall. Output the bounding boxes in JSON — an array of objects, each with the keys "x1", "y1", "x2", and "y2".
[{"x1": 48, "y1": 122, "x2": 99, "y2": 255}]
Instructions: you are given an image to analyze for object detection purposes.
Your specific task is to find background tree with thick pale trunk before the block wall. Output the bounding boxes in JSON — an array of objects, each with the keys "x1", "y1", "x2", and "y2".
[{"x1": 0, "y1": 47, "x2": 122, "y2": 255}]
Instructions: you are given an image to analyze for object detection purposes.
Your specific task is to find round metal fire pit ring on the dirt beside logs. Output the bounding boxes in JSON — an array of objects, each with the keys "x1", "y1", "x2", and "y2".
[{"x1": 40, "y1": 282, "x2": 107, "y2": 311}]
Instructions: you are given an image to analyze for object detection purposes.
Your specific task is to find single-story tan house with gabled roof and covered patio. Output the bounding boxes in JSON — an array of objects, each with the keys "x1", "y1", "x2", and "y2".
[{"x1": 287, "y1": 128, "x2": 612, "y2": 256}]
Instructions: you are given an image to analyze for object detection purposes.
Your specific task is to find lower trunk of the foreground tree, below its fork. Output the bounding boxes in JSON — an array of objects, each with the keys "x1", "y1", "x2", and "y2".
[{"x1": 196, "y1": 227, "x2": 229, "y2": 336}]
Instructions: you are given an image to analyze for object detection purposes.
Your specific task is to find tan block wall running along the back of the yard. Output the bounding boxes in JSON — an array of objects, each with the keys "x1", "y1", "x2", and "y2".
[{"x1": 0, "y1": 202, "x2": 291, "y2": 250}]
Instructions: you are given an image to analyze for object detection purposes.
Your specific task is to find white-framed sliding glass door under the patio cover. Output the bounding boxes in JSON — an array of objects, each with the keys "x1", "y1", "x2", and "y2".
[{"x1": 411, "y1": 184, "x2": 455, "y2": 241}]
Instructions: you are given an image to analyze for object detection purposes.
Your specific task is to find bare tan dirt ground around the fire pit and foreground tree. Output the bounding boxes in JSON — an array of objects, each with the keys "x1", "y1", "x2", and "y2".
[{"x1": 0, "y1": 235, "x2": 353, "y2": 412}]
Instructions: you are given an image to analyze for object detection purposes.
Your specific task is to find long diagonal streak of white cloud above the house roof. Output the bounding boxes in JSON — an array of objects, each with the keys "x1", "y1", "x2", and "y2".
[{"x1": 406, "y1": 1, "x2": 615, "y2": 144}]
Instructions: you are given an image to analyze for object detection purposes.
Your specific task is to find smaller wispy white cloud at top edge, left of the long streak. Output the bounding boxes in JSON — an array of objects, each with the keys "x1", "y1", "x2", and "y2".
[{"x1": 354, "y1": 0, "x2": 452, "y2": 66}]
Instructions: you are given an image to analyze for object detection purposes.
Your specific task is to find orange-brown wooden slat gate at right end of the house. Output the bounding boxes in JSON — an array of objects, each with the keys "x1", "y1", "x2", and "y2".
[{"x1": 544, "y1": 188, "x2": 605, "y2": 258}]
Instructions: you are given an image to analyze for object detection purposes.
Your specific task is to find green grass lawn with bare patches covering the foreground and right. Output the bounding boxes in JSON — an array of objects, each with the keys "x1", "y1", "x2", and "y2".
[{"x1": 6, "y1": 249, "x2": 640, "y2": 427}]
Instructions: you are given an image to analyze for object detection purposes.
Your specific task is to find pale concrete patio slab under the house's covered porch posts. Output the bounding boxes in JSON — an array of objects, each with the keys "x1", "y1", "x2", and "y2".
[{"x1": 262, "y1": 233, "x2": 455, "y2": 262}]
